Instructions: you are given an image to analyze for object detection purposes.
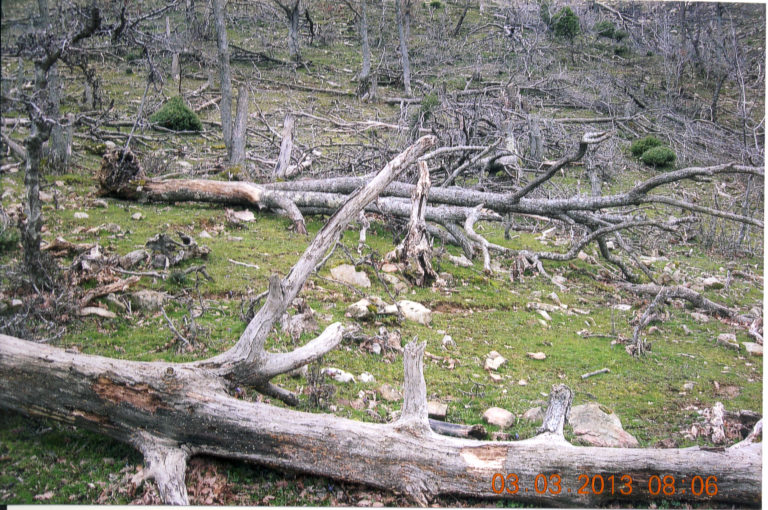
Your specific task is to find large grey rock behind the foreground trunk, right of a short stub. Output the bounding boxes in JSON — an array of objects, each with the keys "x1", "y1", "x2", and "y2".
[{"x1": 569, "y1": 402, "x2": 639, "y2": 448}]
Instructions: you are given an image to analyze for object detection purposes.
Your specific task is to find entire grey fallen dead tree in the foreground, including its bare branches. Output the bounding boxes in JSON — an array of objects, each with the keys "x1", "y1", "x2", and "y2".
[{"x1": 0, "y1": 137, "x2": 762, "y2": 506}]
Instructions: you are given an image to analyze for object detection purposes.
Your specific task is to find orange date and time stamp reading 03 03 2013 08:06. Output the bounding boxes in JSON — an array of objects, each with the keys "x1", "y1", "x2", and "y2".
[{"x1": 491, "y1": 473, "x2": 717, "y2": 498}]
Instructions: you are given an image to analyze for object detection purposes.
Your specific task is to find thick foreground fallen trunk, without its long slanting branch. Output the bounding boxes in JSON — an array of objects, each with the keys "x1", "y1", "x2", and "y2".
[{"x1": 0, "y1": 336, "x2": 762, "y2": 506}]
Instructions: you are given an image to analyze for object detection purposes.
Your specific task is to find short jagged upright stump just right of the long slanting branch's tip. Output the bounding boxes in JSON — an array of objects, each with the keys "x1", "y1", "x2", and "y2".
[{"x1": 384, "y1": 161, "x2": 437, "y2": 287}]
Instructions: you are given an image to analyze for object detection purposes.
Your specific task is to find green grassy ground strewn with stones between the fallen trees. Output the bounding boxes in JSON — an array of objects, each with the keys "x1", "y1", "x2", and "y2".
[{"x1": 0, "y1": 0, "x2": 763, "y2": 507}]
